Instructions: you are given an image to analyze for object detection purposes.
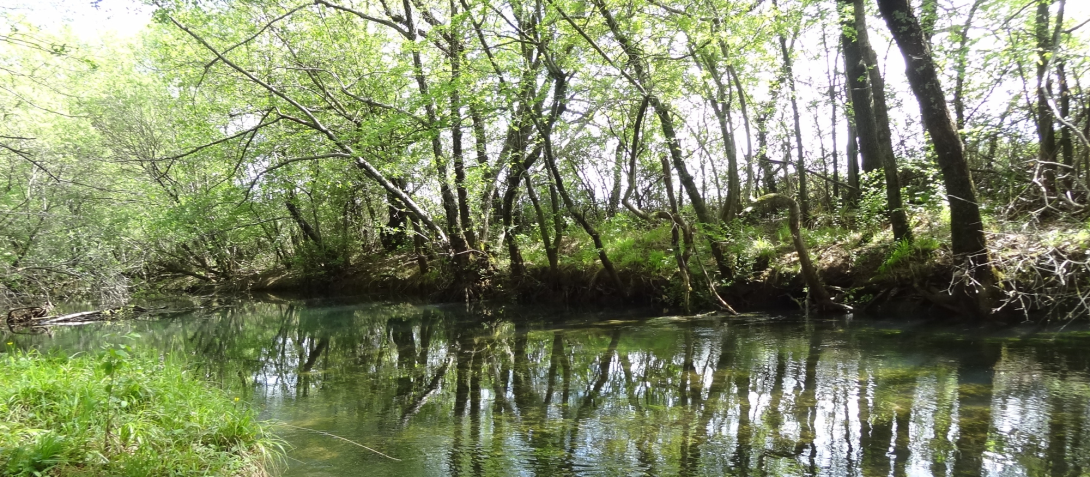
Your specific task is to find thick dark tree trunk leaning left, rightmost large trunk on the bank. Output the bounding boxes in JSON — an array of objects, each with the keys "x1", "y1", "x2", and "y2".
[{"x1": 879, "y1": 0, "x2": 1001, "y2": 317}]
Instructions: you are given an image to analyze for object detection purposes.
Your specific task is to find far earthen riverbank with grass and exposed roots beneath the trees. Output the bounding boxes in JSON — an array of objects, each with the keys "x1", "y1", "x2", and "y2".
[{"x1": 161, "y1": 215, "x2": 1090, "y2": 321}]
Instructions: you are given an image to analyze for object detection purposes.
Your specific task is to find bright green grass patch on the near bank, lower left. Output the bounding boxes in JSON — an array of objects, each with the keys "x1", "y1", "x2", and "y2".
[{"x1": 0, "y1": 343, "x2": 281, "y2": 476}]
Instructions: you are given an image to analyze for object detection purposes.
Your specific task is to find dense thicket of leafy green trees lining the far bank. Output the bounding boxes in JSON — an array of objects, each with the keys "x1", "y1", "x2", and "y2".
[{"x1": 0, "y1": 0, "x2": 1090, "y2": 315}]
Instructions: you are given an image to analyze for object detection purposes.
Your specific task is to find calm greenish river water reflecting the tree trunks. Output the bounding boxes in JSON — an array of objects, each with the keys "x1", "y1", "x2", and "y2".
[{"x1": 12, "y1": 302, "x2": 1090, "y2": 476}]
